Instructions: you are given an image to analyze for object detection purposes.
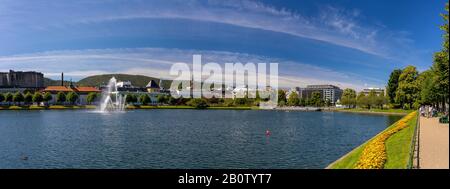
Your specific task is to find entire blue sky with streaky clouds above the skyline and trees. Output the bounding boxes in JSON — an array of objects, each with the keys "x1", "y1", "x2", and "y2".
[{"x1": 0, "y1": 0, "x2": 446, "y2": 89}]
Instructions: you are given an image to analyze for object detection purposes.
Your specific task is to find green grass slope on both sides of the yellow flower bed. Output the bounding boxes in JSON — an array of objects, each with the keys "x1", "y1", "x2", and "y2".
[{"x1": 329, "y1": 111, "x2": 417, "y2": 169}]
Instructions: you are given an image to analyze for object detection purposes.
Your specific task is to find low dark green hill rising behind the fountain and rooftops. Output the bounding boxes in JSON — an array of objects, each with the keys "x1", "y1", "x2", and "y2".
[{"x1": 76, "y1": 74, "x2": 171, "y2": 88}]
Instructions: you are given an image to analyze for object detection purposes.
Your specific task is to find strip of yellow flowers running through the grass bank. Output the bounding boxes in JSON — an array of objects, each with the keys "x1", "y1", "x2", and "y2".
[{"x1": 356, "y1": 112, "x2": 416, "y2": 169}]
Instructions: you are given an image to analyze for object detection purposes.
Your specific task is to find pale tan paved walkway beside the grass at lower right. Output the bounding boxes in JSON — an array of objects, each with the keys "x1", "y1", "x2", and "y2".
[{"x1": 419, "y1": 117, "x2": 449, "y2": 169}]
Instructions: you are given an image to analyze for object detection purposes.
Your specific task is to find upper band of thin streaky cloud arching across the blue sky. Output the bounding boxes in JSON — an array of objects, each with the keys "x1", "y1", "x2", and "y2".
[{"x1": 0, "y1": 0, "x2": 411, "y2": 59}]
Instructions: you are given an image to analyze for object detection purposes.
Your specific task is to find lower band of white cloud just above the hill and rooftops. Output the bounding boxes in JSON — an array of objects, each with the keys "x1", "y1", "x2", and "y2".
[{"x1": 0, "y1": 48, "x2": 382, "y2": 90}]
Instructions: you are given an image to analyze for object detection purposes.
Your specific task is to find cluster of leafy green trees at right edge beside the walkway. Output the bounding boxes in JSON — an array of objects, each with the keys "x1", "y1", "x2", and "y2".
[{"x1": 387, "y1": 3, "x2": 449, "y2": 111}]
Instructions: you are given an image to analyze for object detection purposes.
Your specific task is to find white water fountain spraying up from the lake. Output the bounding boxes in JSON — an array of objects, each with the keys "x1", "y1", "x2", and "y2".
[{"x1": 100, "y1": 77, "x2": 126, "y2": 112}]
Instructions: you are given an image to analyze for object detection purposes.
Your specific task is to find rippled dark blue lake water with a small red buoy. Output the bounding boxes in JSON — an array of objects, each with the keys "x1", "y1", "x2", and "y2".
[{"x1": 0, "y1": 110, "x2": 400, "y2": 169}]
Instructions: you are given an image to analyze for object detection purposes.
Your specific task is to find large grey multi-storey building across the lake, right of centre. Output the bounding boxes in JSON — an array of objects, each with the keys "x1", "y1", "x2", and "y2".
[{"x1": 297, "y1": 85, "x2": 342, "y2": 104}]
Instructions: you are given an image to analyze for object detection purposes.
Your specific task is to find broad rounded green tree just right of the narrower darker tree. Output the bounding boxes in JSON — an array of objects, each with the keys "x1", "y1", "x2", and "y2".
[{"x1": 395, "y1": 66, "x2": 419, "y2": 109}]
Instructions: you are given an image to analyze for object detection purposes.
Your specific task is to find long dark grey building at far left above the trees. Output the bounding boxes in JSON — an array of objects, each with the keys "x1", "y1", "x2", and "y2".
[{"x1": 0, "y1": 70, "x2": 44, "y2": 88}]
